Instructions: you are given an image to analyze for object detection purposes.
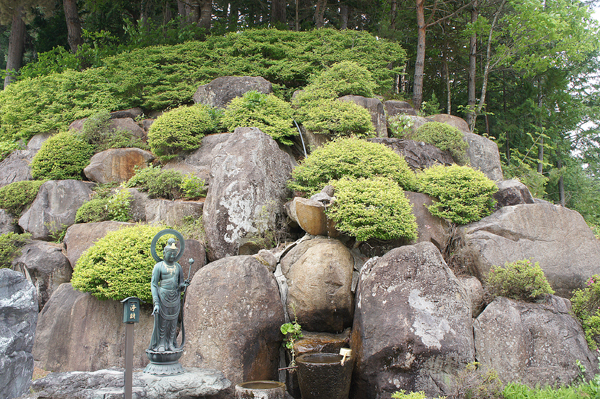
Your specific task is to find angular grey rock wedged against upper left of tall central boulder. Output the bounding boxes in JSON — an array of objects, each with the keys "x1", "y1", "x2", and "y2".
[{"x1": 163, "y1": 133, "x2": 232, "y2": 185}]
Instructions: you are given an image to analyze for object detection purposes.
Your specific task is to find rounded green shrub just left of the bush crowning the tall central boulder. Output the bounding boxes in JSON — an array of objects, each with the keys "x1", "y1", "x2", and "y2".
[{"x1": 148, "y1": 105, "x2": 217, "y2": 162}]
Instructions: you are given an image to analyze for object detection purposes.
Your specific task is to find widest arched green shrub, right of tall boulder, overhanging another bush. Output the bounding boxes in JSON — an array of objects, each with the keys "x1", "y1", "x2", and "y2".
[{"x1": 288, "y1": 137, "x2": 416, "y2": 195}]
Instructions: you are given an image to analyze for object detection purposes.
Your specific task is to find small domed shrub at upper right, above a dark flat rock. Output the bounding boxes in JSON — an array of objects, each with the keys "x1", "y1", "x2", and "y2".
[{"x1": 411, "y1": 122, "x2": 469, "y2": 165}]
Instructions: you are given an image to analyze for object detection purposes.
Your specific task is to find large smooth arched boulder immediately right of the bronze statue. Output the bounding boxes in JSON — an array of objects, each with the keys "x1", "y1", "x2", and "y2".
[{"x1": 181, "y1": 256, "x2": 284, "y2": 384}]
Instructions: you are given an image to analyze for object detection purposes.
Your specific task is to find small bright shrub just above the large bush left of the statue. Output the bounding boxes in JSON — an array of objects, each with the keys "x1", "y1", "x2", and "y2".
[{"x1": 75, "y1": 188, "x2": 131, "y2": 223}]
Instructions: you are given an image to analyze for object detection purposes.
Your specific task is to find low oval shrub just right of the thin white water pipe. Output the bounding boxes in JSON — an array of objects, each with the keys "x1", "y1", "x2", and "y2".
[{"x1": 298, "y1": 99, "x2": 375, "y2": 137}]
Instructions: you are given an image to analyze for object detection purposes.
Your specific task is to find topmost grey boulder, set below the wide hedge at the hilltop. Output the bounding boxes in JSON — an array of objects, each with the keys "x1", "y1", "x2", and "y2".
[{"x1": 193, "y1": 76, "x2": 273, "y2": 108}]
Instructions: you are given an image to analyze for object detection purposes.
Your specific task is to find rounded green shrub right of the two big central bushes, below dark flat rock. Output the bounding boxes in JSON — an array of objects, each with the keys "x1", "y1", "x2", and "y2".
[{"x1": 417, "y1": 165, "x2": 498, "y2": 224}]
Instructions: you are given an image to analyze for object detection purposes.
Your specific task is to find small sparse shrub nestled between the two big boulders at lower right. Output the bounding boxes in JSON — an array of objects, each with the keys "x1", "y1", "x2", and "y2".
[{"x1": 487, "y1": 259, "x2": 554, "y2": 301}]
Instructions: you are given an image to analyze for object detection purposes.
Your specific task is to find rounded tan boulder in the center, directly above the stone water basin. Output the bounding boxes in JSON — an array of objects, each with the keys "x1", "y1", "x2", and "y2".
[{"x1": 280, "y1": 237, "x2": 354, "y2": 333}]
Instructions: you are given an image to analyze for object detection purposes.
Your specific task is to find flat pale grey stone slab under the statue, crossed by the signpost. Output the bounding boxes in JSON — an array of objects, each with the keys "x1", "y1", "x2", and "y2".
[{"x1": 26, "y1": 368, "x2": 231, "y2": 399}]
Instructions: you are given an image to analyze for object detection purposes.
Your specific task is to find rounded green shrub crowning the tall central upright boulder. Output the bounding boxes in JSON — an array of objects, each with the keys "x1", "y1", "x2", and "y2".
[{"x1": 221, "y1": 90, "x2": 298, "y2": 145}]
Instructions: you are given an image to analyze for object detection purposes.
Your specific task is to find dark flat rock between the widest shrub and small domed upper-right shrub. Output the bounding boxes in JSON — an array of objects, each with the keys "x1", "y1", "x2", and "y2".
[{"x1": 368, "y1": 138, "x2": 454, "y2": 170}]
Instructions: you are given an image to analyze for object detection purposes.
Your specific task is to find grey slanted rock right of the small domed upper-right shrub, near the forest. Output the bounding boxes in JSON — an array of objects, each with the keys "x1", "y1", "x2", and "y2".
[{"x1": 463, "y1": 132, "x2": 504, "y2": 182}]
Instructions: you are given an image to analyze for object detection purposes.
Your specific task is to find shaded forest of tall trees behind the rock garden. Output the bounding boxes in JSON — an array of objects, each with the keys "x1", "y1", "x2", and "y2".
[{"x1": 0, "y1": 0, "x2": 600, "y2": 225}]
